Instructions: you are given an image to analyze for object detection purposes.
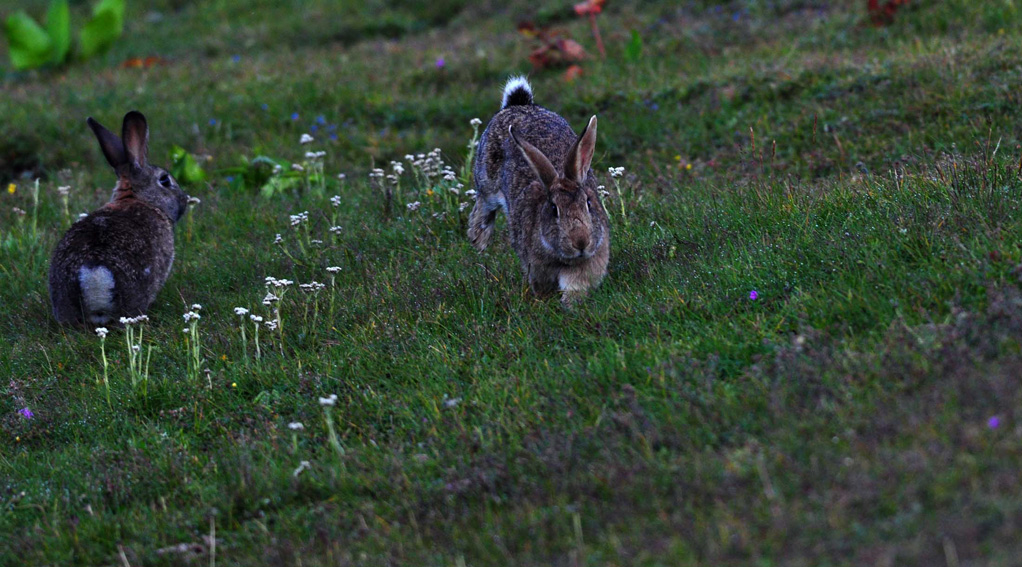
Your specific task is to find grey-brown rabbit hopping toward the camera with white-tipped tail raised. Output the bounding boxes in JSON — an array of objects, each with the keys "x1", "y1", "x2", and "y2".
[{"x1": 468, "y1": 77, "x2": 610, "y2": 305}]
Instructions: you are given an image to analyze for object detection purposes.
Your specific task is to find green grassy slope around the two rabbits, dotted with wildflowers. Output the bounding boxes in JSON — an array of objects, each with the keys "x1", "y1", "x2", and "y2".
[{"x1": 0, "y1": 0, "x2": 1022, "y2": 565}]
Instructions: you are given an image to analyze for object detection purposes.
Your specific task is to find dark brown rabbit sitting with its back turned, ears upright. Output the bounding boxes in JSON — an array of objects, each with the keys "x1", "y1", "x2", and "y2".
[{"x1": 50, "y1": 110, "x2": 188, "y2": 325}]
